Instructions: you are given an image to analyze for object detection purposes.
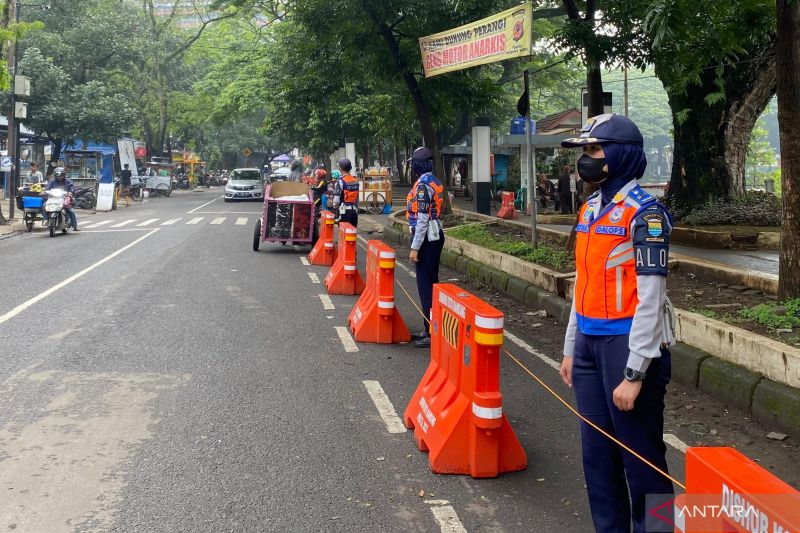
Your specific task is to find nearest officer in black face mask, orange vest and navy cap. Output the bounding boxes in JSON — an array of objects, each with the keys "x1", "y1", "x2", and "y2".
[{"x1": 561, "y1": 113, "x2": 674, "y2": 533}]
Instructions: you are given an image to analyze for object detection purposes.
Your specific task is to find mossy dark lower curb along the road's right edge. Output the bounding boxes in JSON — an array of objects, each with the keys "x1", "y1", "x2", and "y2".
[{"x1": 383, "y1": 214, "x2": 800, "y2": 438}]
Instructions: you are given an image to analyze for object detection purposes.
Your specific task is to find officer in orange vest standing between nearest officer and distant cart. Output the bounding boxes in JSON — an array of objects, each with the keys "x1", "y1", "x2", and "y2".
[{"x1": 406, "y1": 147, "x2": 444, "y2": 348}]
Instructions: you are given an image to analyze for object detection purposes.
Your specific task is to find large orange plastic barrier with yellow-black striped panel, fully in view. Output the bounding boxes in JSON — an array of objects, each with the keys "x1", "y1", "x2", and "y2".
[{"x1": 403, "y1": 283, "x2": 527, "y2": 478}]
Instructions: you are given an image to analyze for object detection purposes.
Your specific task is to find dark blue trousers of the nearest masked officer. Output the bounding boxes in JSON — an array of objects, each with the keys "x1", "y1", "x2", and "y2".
[{"x1": 572, "y1": 332, "x2": 674, "y2": 533}]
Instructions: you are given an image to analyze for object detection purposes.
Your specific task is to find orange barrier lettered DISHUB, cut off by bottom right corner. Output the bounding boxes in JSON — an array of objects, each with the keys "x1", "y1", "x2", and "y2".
[{"x1": 668, "y1": 447, "x2": 800, "y2": 533}]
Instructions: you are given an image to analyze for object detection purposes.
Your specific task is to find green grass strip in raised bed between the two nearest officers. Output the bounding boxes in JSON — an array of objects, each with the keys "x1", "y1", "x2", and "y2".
[{"x1": 448, "y1": 225, "x2": 575, "y2": 270}]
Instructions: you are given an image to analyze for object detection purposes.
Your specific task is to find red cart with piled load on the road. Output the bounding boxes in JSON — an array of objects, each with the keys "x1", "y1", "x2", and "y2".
[{"x1": 253, "y1": 181, "x2": 315, "y2": 252}]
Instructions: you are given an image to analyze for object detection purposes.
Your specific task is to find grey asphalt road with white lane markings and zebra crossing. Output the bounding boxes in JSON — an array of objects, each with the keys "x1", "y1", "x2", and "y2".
[{"x1": 0, "y1": 189, "x2": 796, "y2": 532}]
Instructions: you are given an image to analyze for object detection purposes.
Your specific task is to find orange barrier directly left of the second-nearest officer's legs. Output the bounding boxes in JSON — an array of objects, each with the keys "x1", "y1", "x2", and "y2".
[{"x1": 347, "y1": 240, "x2": 411, "y2": 344}]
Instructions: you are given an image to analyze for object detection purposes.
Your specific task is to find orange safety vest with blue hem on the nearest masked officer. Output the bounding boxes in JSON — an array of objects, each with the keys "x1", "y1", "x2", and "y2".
[{"x1": 575, "y1": 185, "x2": 656, "y2": 335}]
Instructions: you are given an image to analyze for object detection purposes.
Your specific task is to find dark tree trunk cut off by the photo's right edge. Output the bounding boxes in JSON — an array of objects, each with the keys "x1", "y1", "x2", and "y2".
[{"x1": 775, "y1": 0, "x2": 800, "y2": 298}]
